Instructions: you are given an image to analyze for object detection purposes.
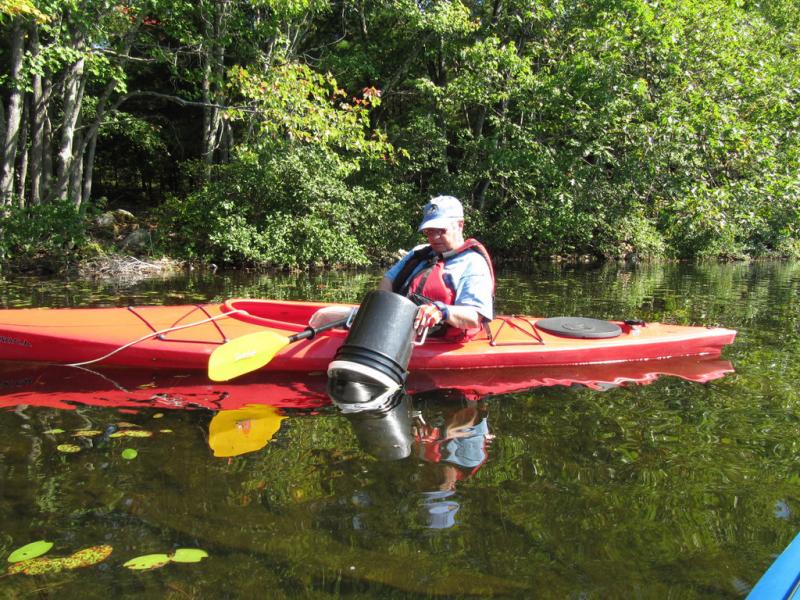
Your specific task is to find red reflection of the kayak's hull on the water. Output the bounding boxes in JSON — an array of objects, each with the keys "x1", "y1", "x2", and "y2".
[{"x1": 0, "y1": 357, "x2": 733, "y2": 410}]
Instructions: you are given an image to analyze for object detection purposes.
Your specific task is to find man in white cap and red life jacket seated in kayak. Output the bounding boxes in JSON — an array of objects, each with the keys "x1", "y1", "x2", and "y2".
[{"x1": 309, "y1": 196, "x2": 494, "y2": 341}]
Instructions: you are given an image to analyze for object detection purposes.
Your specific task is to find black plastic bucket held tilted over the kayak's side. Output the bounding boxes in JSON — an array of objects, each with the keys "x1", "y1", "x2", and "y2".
[{"x1": 328, "y1": 291, "x2": 418, "y2": 388}]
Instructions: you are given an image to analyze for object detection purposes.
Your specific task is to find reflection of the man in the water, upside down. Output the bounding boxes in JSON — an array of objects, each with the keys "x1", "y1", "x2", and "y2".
[{"x1": 413, "y1": 402, "x2": 493, "y2": 529}]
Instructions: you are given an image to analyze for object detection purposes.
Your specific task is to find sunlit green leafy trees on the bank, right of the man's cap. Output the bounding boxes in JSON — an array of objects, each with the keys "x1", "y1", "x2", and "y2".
[{"x1": 308, "y1": 0, "x2": 800, "y2": 257}]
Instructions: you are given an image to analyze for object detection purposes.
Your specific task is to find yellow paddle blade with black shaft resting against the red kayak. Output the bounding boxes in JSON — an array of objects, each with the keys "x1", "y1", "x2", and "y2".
[{"x1": 208, "y1": 317, "x2": 349, "y2": 381}]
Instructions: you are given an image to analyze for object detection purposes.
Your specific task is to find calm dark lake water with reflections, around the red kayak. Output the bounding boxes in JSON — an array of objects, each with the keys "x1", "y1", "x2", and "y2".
[{"x1": 0, "y1": 263, "x2": 800, "y2": 599}]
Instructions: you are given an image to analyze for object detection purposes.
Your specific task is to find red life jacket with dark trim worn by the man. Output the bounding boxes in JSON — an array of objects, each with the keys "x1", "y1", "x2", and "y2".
[{"x1": 392, "y1": 238, "x2": 495, "y2": 341}]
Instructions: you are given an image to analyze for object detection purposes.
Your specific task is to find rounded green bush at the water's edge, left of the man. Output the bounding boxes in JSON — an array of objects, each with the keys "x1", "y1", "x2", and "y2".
[{"x1": 159, "y1": 145, "x2": 410, "y2": 268}]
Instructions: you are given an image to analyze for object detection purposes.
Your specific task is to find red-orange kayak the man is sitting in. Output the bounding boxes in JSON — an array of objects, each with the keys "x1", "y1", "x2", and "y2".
[{"x1": 0, "y1": 300, "x2": 736, "y2": 372}]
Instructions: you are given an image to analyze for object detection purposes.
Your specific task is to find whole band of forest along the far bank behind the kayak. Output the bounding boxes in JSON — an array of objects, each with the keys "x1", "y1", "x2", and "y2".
[{"x1": 0, "y1": 0, "x2": 800, "y2": 267}]
